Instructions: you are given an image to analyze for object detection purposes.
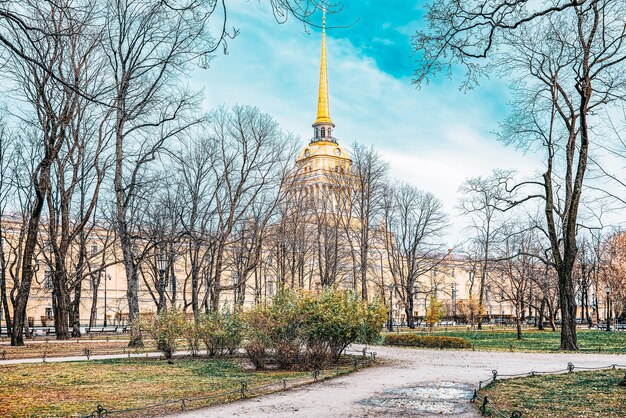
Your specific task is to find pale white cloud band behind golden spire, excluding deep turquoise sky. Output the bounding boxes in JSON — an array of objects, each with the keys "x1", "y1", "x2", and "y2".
[{"x1": 193, "y1": 5, "x2": 539, "y2": 244}]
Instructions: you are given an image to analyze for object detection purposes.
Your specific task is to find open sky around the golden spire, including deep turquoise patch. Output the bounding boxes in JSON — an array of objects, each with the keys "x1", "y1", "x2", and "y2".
[{"x1": 191, "y1": 0, "x2": 539, "y2": 245}]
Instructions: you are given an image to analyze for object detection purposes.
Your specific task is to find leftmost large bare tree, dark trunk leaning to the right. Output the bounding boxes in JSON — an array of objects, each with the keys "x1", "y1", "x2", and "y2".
[{"x1": 3, "y1": 4, "x2": 101, "y2": 345}]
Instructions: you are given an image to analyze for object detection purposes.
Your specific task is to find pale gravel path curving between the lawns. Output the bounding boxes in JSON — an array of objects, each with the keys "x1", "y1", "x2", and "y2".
[{"x1": 175, "y1": 347, "x2": 626, "y2": 418}]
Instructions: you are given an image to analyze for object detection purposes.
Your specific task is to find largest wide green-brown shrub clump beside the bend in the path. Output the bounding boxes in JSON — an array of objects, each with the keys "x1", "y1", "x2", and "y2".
[{"x1": 244, "y1": 289, "x2": 387, "y2": 369}]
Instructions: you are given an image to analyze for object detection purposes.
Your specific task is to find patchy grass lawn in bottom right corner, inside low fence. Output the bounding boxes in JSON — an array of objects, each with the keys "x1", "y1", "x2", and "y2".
[{"x1": 481, "y1": 370, "x2": 626, "y2": 418}]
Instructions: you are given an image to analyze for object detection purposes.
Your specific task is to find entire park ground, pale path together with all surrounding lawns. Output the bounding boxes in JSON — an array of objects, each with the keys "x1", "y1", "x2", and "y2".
[{"x1": 0, "y1": 329, "x2": 626, "y2": 418}]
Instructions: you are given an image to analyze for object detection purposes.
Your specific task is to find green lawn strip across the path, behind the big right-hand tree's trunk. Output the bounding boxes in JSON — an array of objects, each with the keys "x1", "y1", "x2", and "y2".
[{"x1": 382, "y1": 329, "x2": 626, "y2": 354}]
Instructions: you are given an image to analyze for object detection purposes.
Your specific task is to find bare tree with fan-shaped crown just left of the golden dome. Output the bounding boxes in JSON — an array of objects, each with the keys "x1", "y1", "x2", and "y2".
[{"x1": 202, "y1": 106, "x2": 294, "y2": 309}]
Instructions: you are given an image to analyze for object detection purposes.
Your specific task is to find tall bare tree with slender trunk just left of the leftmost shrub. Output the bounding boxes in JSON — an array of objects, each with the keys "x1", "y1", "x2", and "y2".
[{"x1": 103, "y1": 0, "x2": 216, "y2": 346}]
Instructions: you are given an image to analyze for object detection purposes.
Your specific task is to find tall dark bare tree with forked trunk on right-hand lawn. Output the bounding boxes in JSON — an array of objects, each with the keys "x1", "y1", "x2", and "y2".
[{"x1": 415, "y1": 0, "x2": 626, "y2": 350}]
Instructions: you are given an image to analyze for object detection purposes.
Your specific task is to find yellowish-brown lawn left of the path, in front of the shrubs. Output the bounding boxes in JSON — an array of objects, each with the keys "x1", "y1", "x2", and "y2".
[{"x1": 0, "y1": 358, "x2": 338, "y2": 417}]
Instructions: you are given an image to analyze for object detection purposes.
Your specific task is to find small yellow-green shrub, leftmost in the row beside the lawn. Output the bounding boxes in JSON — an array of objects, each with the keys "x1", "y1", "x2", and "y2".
[{"x1": 141, "y1": 308, "x2": 187, "y2": 360}]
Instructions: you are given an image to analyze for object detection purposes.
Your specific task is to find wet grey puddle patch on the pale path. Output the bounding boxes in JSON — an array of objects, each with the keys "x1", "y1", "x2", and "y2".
[{"x1": 359, "y1": 382, "x2": 473, "y2": 416}]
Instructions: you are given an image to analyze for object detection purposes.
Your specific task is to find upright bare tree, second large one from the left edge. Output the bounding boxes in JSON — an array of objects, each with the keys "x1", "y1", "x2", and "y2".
[{"x1": 46, "y1": 11, "x2": 109, "y2": 340}]
